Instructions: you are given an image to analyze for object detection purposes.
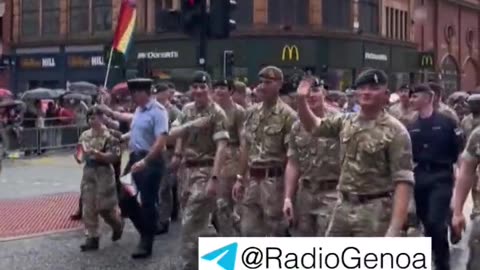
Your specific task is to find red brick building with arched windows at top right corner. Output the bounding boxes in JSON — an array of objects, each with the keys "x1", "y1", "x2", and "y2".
[{"x1": 413, "y1": 0, "x2": 480, "y2": 95}]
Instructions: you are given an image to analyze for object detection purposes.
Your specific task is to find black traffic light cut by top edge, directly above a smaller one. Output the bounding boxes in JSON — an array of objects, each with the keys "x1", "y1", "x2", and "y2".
[{"x1": 209, "y1": 0, "x2": 237, "y2": 38}]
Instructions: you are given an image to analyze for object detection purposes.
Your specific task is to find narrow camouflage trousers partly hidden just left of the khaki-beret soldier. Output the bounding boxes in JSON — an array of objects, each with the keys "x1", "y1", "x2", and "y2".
[{"x1": 215, "y1": 147, "x2": 239, "y2": 236}]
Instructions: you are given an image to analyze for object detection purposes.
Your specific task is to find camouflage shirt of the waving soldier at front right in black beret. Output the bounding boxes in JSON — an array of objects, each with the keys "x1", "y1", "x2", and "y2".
[{"x1": 312, "y1": 112, "x2": 414, "y2": 194}]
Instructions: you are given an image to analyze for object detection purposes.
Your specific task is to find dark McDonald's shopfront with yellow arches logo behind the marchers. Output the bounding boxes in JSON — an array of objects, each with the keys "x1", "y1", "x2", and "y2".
[{"x1": 128, "y1": 37, "x2": 417, "y2": 90}]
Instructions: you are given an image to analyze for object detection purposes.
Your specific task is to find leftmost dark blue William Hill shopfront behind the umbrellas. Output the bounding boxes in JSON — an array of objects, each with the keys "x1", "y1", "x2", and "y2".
[{"x1": 12, "y1": 49, "x2": 65, "y2": 92}]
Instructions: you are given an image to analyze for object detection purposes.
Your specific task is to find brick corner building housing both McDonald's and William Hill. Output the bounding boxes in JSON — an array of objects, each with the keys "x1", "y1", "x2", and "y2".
[{"x1": 7, "y1": 0, "x2": 419, "y2": 91}]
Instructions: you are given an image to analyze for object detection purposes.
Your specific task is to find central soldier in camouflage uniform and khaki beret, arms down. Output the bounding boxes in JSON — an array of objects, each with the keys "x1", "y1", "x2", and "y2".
[{"x1": 233, "y1": 66, "x2": 296, "y2": 236}]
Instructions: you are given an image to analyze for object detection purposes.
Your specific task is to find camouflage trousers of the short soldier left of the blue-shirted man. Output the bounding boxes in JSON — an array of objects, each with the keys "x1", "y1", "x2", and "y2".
[{"x1": 81, "y1": 166, "x2": 122, "y2": 237}]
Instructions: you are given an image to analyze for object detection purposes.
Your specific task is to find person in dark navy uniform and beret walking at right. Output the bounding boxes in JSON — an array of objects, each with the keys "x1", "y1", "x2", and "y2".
[{"x1": 407, "y1": 84, "x2": 463, "y2": 270}]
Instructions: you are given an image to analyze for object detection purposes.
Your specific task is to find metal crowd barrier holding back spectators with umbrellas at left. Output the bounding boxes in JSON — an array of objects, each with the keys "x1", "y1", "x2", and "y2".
[{"x1": 0, "y1": 125, "x2": 88, "y2": 154}]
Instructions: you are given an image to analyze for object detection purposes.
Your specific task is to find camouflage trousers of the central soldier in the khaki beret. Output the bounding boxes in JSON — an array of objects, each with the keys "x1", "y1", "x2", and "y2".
[{"x1": 240, "y1": 177, "x2": 288, "y2": 237}]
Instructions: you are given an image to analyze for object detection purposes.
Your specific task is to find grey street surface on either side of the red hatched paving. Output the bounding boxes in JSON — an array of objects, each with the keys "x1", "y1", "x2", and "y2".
[{"x1": 0, "y1": 154, "x2": 471, "y2": 270}]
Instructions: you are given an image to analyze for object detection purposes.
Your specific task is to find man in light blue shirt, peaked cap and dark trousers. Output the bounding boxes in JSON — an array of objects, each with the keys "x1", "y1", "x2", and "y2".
[{"x1": 127, "y1": 79, "x2": 168, "y2": 259}]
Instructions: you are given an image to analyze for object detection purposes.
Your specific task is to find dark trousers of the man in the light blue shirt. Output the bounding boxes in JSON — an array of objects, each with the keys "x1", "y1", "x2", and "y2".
[{"x1": 128, "y1": 152, "x2": 165, "y2": 241}]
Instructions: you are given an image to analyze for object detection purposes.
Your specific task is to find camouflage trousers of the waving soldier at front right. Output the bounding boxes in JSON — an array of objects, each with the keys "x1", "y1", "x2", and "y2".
[{"x1": 326, "y1": 195, "x2": 392, "y2": 237}]
